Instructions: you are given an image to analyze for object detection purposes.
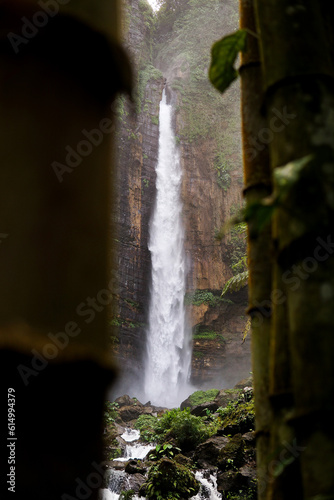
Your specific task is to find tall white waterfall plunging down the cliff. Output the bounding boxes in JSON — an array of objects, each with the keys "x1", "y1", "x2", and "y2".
[{"x1": 145, "y1": 90, "x2": 191, "y2": 407}]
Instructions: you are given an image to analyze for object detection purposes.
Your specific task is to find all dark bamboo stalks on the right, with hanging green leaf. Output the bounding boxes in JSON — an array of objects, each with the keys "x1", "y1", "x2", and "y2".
[{"x1": 210, "y1": 0, "x2": 334, "y2": 500}]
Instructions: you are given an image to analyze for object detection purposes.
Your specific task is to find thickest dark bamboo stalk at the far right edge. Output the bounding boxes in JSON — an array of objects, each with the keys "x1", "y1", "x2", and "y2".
[{"x1": 254, "y1": 0, "x2": 334, "y2": 499}]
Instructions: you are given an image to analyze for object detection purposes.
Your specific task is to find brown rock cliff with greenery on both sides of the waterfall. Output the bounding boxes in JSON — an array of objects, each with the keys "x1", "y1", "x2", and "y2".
[{"x1": 113, "y1": 0, "x2": 250, "y2": 390}]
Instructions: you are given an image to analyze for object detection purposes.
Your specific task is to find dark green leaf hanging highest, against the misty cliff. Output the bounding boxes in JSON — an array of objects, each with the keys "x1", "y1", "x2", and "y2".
[{"x1": 209, "y1": 30, "x2": 247, "y2": 92}]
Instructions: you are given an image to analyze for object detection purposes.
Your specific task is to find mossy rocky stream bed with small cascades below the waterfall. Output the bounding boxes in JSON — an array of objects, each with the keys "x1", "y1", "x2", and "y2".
[{"x1": 100, "y1": 378, "x2": 257, "y2": 500}]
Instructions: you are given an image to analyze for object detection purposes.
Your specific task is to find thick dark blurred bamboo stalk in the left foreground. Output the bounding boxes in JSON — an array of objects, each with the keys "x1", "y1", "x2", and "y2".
[{"x1": 0, "y1": 0, "x2": 130, "y2": 500}]
